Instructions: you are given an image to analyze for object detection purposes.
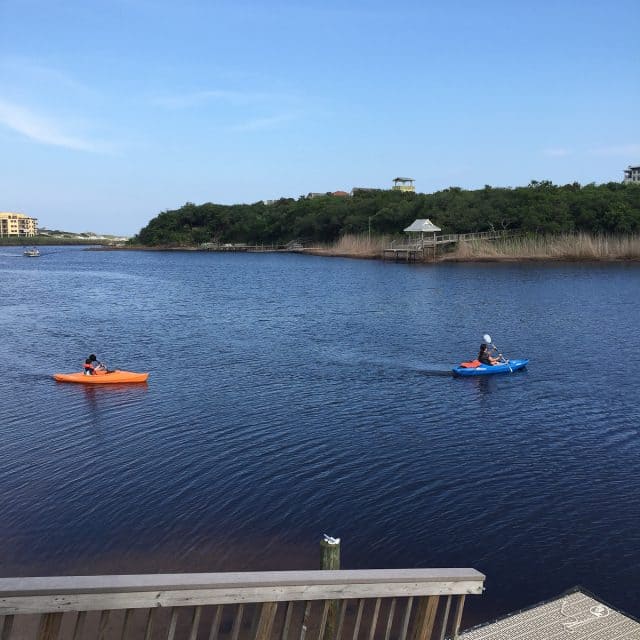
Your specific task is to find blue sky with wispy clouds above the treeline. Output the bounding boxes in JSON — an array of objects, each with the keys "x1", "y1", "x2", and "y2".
[{"x1": 0, "y1": 0, "x2": 640, "y2": 235}]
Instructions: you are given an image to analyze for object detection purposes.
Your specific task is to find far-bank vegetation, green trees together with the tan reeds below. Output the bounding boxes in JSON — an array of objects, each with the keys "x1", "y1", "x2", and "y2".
[{"x1": 131, "y1": 181, "x2": 640, "y2": 260}]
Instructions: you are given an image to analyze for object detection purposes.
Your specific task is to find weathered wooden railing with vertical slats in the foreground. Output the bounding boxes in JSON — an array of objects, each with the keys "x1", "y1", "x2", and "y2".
[{"x1": 0, "y1": 569, "x2": 484, "y2": 640}]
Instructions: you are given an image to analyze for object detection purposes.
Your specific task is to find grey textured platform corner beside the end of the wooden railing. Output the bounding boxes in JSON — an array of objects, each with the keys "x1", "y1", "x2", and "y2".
[{"x1": 460, "y1": 589, "x2": 640, "y2": 640}]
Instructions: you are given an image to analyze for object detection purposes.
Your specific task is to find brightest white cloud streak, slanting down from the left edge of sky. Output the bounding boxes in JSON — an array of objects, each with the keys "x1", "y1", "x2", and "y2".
[{"x1": 0, "y1": 100, "x2": 107, "y2": 153}]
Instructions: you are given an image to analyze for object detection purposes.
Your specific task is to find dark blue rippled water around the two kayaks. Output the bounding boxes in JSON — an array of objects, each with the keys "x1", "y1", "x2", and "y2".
[{"x1": 0, "y1": 247, "x2": 640, "y2": 619}]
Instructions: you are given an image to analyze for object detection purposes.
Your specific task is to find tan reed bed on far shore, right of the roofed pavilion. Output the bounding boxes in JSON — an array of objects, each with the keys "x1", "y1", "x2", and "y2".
[{"x1": 441, "y1": 233, "x2": 640, "y2": 261}]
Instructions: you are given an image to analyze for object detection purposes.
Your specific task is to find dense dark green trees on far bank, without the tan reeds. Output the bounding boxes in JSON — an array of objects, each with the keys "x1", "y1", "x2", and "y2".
[{"x1": 132, "y1": 181, "x2": 640, "y2": 246}]
